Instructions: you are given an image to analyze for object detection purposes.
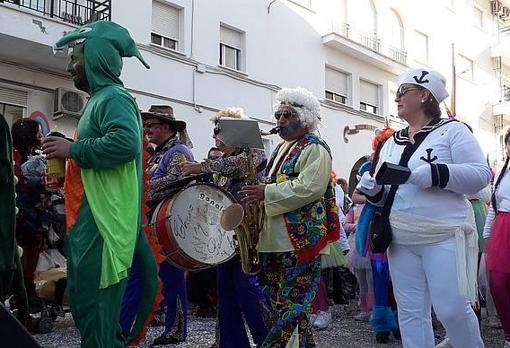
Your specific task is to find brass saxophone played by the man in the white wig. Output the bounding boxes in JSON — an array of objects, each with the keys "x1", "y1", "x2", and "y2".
[{"x1": 221, "y1": 148, "x2": 264, "y2": 275}]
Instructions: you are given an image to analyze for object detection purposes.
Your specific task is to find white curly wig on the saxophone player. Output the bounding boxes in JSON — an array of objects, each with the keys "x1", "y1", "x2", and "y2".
[{"x1": 274, "y1": 87, "x2": 321, "y2": 131}]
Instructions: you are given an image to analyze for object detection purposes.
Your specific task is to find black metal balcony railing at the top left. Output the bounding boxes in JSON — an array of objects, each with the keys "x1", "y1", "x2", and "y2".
[{"x1": 0, "y1": 0, "x2": 111, "y2": 25}]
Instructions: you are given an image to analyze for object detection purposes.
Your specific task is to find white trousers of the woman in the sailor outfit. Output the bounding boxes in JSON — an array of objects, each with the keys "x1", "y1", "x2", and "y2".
[{"x1": 388, "y1": 237, "x2": 484, "y2": 348}]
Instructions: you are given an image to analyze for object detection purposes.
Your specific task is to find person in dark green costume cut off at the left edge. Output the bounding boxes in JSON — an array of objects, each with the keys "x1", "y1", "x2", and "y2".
[{"x1": 0, "y1": 114, "x2": 30, "y2": 327}]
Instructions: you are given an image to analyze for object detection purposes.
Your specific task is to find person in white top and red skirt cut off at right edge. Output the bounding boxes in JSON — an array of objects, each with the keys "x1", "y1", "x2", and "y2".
[{"x1": 483, "y1": 130, "x2": 510, "y2": 348}]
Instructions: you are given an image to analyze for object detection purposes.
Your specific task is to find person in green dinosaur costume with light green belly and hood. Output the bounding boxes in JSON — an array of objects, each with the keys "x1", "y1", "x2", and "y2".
[{"x1": 43, "y1": 21, "x2": 157, "y2": 348}]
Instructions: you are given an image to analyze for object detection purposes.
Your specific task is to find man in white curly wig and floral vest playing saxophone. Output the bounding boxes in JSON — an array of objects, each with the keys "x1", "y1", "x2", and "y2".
[{"x1": 240, "y1": 88, "x2": 340, "y2": 348}]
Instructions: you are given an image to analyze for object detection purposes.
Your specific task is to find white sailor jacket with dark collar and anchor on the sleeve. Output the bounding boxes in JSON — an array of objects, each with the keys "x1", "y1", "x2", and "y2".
[{"x1": 358, "y1": 119, "x2": 491, "y2": 224}]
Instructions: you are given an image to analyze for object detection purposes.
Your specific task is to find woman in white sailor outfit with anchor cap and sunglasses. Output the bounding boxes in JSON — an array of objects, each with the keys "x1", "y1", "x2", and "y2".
[{"x1": 358, "y1": 69, "x2": 491, "y2": 348}]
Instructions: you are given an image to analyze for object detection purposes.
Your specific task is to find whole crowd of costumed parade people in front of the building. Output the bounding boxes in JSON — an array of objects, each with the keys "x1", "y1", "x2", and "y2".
[{"x1": 0, "y1": 21, "x2": 510, "y2": 348}]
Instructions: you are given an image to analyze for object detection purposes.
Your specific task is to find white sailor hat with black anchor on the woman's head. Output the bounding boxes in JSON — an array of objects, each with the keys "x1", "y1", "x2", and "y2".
[{"x1": 398, "y1": 68, "x2": 449, "y2": 103}]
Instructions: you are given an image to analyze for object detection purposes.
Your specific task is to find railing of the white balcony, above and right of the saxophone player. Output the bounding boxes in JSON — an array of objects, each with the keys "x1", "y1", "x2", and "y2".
[{"x1": 331, "y1": 22, "x2": 407, "y2": 64}]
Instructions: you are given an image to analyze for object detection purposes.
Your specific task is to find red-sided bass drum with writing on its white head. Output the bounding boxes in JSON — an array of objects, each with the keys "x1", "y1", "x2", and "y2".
[{"x1": 151, "y1": 183, "x2": 235, "y2": 270}]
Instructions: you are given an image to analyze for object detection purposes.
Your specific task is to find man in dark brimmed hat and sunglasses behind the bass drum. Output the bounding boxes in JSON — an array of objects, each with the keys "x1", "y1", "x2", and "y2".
[{"x1": 142, "y1": 105, "x2": 193, "y2": 345}]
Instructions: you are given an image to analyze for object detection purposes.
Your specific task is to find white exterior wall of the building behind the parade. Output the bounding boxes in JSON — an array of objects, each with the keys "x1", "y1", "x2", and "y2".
[{"x1": 0, "y1": 0, "x2": 510, "y2": 178}]
